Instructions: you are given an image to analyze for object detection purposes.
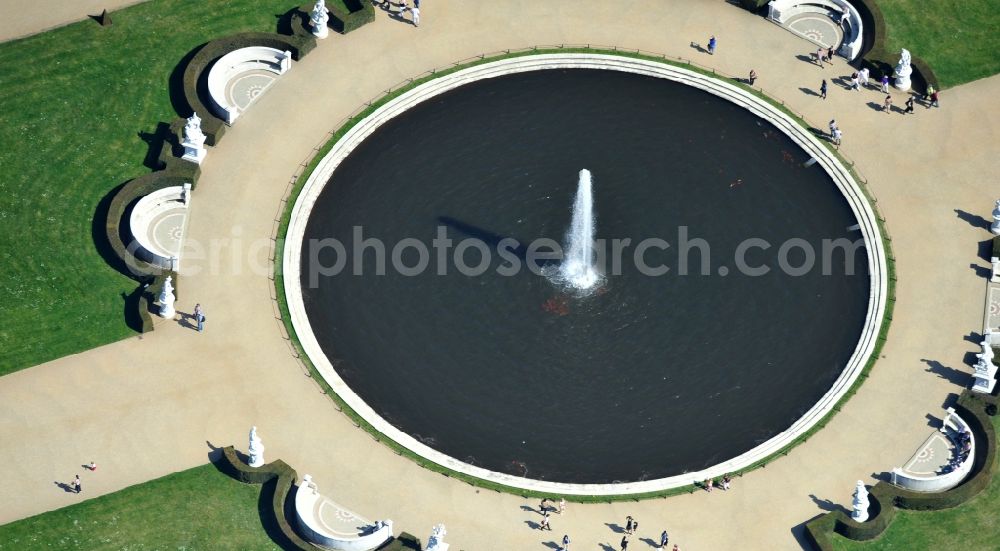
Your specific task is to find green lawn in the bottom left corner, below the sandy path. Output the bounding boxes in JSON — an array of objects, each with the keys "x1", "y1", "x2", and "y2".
[{"x1": 0, "y1": 465, "x2": 280, "y2": 551}]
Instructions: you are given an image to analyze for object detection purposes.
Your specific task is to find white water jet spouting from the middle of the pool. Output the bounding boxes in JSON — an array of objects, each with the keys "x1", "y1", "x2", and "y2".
[{"x1": 559, "y1": 169, "x2": 601, "y2": 290}]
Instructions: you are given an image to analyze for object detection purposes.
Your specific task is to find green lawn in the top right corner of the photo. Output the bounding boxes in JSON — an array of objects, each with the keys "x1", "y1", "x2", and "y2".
[{"x1": 878, "y1": 0, "x2": 1000, "y2": 88}]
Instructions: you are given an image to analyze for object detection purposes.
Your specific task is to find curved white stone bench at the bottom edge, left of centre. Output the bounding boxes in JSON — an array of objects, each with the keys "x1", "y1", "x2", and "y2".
[{"x1": 295, "y1": 475, "x2": 393, "y2": 551}]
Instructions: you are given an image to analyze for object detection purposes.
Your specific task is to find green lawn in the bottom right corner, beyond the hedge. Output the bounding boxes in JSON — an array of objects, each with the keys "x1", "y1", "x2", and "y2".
[{"x1": 830, "y1": 416, "x2": 1000, "y2": 551}]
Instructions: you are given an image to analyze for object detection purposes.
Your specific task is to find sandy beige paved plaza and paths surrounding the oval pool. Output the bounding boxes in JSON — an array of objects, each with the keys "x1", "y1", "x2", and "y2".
[{"x1": 0, "y1": 0, "x2": 1000, "y2": 551}]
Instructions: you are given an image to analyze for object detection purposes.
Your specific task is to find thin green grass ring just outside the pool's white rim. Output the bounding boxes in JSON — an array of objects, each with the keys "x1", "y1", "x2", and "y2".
[{"x1": 272, "y1": 45, "x2": 896, "y2": 503}]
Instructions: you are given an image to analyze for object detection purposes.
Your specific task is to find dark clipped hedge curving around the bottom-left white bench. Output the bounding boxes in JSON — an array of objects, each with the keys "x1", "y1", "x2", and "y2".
[{"x1": 215, "y1": 446, "x2": 421, "y2": 551}]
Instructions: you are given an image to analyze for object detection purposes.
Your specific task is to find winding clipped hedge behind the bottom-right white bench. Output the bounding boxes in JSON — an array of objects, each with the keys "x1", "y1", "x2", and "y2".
[{"x1": 806, "y1": 390, "x2": 997, "y2": 551}]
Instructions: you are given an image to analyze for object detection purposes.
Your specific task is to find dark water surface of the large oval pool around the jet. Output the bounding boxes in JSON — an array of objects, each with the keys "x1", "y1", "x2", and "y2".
[{"x1": 302, "y1": 70, "x2": 869, "y2": 483}]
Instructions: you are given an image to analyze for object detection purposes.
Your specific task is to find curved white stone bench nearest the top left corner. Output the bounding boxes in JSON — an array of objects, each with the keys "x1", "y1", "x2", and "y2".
[{"x1": 208, "y1": 46, "x2": 292, "y2": 125}]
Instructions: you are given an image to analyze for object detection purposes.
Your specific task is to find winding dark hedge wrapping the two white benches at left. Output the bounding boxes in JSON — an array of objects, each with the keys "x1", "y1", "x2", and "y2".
[{"x1": 104, "y1": 15, "x2": 316, "y2": 333}]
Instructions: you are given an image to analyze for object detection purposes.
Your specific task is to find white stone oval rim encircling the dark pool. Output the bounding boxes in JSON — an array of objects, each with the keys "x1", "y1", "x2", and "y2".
[{"x1": 282, "y1": 53, "x2": 888, "y2": 495}]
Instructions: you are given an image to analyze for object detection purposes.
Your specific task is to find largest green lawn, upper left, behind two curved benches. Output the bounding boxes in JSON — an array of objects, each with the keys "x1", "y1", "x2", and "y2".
[{"x1": 0, "y1": 0, "x2": 297, "y2": 375}]
